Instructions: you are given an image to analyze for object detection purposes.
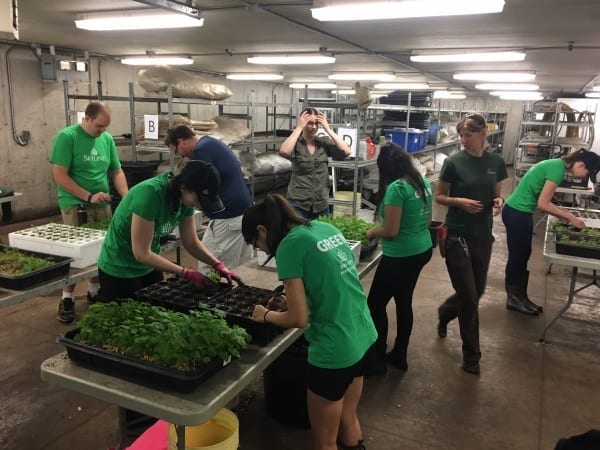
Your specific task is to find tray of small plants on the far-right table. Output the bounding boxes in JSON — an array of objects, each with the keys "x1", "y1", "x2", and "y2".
[{"x1": 550, "y1": 222, "x2": 600, "y2": 258}]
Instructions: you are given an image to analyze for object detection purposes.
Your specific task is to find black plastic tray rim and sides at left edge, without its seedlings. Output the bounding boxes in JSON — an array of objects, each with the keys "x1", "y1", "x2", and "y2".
[{"x1": 0, "y1": 245, "x2": 72, "y2": 290}]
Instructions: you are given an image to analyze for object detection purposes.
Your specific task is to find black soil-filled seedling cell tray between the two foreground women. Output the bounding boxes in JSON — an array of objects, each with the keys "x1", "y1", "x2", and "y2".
[{"x1": 136, "y1": 277, "x2": 281, "y2": 346}]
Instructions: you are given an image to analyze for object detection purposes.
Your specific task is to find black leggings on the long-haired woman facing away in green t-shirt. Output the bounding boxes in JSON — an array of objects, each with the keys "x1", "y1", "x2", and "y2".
[{"x1": 368, "y1": 249, "x2": 432, "y2": 359}]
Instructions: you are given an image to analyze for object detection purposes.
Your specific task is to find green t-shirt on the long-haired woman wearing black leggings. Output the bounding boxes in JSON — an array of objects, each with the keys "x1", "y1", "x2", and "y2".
[{"x1": 379, "y1": 178, "x2": 432, "y2": 257}]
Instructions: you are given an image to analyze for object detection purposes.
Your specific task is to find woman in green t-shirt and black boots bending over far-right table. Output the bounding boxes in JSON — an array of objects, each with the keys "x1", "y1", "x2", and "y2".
[{"x1": 502, "y1": 149, "x2": 600, "y2": 315}]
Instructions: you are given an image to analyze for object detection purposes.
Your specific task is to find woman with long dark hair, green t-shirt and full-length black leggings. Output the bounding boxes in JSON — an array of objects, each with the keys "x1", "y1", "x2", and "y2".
[{"x1": 366, "y1": 143, "x2": 432, "y2": 375}]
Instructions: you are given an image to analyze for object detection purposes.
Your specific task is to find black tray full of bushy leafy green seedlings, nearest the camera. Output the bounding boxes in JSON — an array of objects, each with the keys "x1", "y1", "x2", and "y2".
[{"x1": 57, "y1": 300, "x2": 250, "y2": 392}]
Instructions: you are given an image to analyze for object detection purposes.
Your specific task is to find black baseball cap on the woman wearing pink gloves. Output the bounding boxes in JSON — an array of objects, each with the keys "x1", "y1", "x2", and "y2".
[{"x1": 180, "y1": 160, "x2": 225, "y2": 213}]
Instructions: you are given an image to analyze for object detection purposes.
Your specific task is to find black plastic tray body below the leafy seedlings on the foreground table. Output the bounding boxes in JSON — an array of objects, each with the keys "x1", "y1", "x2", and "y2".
[{"x1": 57, "y1": 328, "x2": 225, "y2": 393}]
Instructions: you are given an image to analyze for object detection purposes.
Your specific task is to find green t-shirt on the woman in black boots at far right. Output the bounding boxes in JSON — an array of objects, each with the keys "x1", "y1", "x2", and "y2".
[{"x1": 506, "y1": 158, "x2": 567, "y2": 213}]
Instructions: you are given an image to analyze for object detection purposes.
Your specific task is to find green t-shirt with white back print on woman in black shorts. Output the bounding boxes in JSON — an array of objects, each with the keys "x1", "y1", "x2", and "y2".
[{"x1": 275, "y1": 221, "x2": 377, "y2": 369}]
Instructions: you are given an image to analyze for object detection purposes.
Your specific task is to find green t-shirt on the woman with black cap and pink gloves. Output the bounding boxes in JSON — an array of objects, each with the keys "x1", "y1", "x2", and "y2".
[{"x1": 98, "y1": 172, "x2": 194, "y2": 278}]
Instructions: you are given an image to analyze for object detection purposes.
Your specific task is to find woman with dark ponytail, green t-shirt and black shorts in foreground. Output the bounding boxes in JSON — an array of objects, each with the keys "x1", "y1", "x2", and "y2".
[{"x1": 242, "y1": 194, "x2": 377, "y2": 450}]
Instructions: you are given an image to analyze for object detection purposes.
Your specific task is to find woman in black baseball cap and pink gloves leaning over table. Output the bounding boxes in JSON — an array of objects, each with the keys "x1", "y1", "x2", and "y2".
[{"x1": 98, "y1": 161, "x2": 239, "y2": 301}]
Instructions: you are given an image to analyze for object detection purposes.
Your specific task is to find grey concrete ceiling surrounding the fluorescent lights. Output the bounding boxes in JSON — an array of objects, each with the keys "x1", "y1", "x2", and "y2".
[{"x1": 10, "y1": 0, "x2": 600, "y2": 95}]
